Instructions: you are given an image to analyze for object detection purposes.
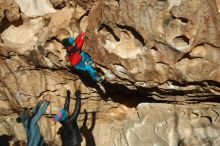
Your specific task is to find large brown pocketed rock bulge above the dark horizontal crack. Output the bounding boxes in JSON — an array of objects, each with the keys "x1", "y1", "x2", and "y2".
[{"x1": 86, "y1": 0, "x2": 220, "y2": 94}]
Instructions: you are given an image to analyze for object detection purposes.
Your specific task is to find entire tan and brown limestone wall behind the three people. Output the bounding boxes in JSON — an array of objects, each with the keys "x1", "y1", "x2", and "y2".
[{"x1": 0, "y1": 0, "x2": 220, "y2": 146}]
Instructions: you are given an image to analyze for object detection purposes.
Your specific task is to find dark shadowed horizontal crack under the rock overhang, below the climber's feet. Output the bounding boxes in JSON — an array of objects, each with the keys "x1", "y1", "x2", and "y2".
[{"x1": 72, "y1": 68, "x2": 220, "y2": 107}]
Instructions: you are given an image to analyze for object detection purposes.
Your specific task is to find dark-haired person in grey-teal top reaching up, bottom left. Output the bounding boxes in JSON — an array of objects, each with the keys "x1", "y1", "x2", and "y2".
[{"x1": 16, "y1": 95, "x2": 51, "y2": 146}]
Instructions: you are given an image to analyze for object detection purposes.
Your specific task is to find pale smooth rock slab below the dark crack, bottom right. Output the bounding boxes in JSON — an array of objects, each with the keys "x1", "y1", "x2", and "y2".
[{"x1": 116, "y1": 103, "x2": 220, "y2": 146}]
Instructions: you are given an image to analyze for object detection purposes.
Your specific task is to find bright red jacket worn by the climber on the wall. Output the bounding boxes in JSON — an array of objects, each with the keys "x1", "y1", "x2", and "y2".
[{"x1": 68, "y1": 32, "x2": 85, "y2": 65}]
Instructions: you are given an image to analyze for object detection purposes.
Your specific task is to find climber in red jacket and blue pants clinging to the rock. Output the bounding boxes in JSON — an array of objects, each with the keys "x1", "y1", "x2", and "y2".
[{"x1": 55, "y1": 32, "x2": 104, "y2": 82}]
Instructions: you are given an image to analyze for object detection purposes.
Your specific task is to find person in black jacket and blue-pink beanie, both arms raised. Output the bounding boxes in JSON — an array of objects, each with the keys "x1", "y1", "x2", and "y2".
[{"x1": 54, "y1": 90, "x2": 82, "y2": 146}]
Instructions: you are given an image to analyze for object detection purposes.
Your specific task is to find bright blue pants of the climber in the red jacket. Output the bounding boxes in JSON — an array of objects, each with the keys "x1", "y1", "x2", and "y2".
[{"x1": 74, "y1": 51, "x2": 97, "y2": 80}]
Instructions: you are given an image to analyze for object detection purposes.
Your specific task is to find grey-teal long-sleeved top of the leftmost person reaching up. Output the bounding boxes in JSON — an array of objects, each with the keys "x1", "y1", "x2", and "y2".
[{"x1": 23, "y1": 100, "x2": 49, "y2": 146}]
